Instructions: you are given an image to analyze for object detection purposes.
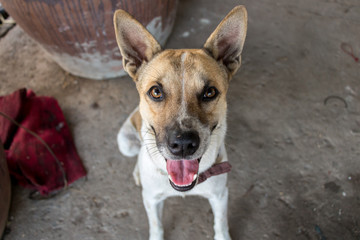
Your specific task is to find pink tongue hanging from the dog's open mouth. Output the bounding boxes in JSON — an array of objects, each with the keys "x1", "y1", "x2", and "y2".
[{"x1": 166, "y1": 159, "x2": 199, "y2": 186}]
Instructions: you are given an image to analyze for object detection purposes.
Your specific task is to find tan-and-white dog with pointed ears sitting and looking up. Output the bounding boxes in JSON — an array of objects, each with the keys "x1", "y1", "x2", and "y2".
[{"x1": 114, "y1": 6, "x2": 247, "y2": 240}]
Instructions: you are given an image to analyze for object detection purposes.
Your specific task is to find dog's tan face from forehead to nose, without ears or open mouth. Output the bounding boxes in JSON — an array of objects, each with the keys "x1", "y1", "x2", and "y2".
[{"x1": 137, "y1": 50, "x2": 228, "y2": 160}]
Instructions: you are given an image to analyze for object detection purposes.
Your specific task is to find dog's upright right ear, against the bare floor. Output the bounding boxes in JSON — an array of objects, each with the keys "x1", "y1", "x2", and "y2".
[{"x1": 204, "y1": 6, "x2": 247, "y2": 77}]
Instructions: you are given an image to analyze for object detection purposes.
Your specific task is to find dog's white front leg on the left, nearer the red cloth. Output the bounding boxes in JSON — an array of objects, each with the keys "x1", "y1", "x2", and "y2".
[{"x1": 142, "y1": 190, "x2": 164, "y2": 240}]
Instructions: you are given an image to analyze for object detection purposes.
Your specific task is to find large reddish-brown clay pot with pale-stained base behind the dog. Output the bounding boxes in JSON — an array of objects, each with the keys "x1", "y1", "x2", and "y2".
[{"x1": 1, "y1": 0, "x2": 178, "y2": 79}]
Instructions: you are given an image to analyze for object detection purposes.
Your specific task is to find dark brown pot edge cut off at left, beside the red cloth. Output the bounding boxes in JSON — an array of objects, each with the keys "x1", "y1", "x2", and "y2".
[{"x1": 0, "y1": 142, "x2": 11, "y2": 238}]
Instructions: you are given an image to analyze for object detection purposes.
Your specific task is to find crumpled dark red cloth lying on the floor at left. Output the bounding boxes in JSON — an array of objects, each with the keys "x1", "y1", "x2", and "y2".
[{"x1": 0, "y1": 89, "x2": 86, "y2": 195}]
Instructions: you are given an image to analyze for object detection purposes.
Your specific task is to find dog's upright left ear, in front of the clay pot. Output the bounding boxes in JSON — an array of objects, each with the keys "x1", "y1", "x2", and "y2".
[{"x1": 114, "y1": 10, "x2": 161, "y2": 80}]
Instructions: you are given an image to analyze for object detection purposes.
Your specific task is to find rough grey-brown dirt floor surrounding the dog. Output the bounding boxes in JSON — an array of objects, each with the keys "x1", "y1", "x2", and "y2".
[{"x1": 0, "y1": 0, "x2": 360, "y2": 240}]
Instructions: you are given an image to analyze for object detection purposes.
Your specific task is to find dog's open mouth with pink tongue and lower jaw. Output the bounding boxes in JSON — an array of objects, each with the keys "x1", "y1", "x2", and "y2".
[{"x1": 166, "y1": 159, "x2": 200, "y2": 192}]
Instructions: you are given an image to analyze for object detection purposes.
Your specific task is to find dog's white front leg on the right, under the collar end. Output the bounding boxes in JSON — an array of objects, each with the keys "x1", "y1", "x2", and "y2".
[{"x1": 209, "y1": 187, "x2": 231, "y2": 240}]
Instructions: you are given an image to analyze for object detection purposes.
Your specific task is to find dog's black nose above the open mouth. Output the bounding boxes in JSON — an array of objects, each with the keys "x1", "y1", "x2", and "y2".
[{"x1": 168, "y1": 131, "x2": 200, "y2": 157}]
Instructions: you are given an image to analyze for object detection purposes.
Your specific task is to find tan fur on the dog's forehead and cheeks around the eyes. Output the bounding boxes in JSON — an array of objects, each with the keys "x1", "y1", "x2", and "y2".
[{"x1": 136, "y1": 50, "x2": 228, "y2": 142}]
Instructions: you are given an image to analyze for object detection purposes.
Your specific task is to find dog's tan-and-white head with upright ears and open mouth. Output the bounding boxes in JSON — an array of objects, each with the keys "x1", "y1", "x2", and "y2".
[{"x1": 114, "y1": 6, "x2": 247, "y2": 191}]
